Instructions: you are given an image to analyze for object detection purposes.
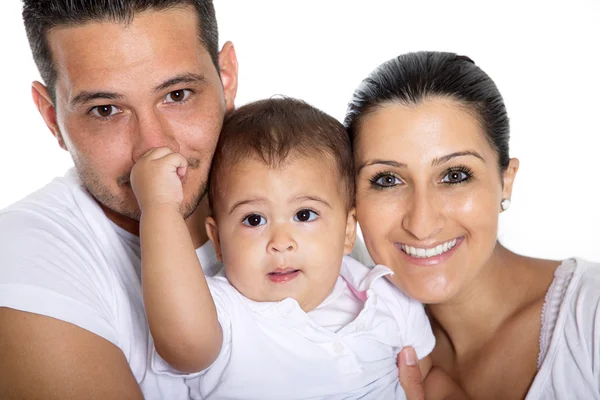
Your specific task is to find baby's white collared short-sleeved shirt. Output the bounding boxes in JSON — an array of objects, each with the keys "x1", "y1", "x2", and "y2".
[{"x1": 152, "y1": 257, "x2": 435, "y2": 400}]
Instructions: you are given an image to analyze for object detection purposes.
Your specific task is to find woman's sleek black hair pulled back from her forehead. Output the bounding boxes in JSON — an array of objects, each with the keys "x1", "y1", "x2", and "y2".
[{"x1": 344, "y1": 51, "x2": 510, "y2": 171}]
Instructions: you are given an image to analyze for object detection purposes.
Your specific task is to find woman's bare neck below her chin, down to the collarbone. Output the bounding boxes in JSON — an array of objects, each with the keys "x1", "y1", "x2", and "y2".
[{"x1": 427, "y1": 243, "x2": 553, "y2": 358}]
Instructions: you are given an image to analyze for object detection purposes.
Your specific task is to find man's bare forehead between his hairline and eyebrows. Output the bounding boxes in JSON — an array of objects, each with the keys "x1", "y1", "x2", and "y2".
[{"x1": 48, "y1": 7, "x2": 212, "y2": 101}]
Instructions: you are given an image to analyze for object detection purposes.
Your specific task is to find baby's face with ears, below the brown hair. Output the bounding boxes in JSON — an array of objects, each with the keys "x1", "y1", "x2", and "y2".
[{"x1": 207, "y1": 157, "x2": 356, "y2": 311}]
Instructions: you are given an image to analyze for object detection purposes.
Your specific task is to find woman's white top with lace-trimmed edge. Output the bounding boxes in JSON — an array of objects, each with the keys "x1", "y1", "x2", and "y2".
[{"x1": 527, "y1": 258, "x2": 600, "y2": 399}]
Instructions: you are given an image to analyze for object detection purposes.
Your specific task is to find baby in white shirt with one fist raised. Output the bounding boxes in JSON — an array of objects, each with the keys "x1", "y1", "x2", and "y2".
[{"x1": 131, "y1": 98, "x2": 435, "y2": 400}]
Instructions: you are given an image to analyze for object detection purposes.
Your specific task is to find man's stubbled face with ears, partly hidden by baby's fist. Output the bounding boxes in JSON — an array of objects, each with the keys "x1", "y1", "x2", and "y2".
[{"x1": 34, "y1": 7, "x2": 237, "y2": 225}]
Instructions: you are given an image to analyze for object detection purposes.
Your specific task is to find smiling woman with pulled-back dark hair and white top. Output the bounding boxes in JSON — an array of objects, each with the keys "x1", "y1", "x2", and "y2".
[{"x1": 345, "y1": 52, "x2": 600, "y2": 399}]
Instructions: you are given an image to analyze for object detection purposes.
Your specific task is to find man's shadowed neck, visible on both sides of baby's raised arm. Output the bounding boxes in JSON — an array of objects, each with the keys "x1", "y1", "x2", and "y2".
[{"x1": 100, "y1": 196, "x2": 209, "y2": 248}]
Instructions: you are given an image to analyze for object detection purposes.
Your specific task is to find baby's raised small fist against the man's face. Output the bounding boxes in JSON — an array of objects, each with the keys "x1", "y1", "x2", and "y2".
[{"x1": 130, "y1": 147, "x2": 188, "y2": 211}]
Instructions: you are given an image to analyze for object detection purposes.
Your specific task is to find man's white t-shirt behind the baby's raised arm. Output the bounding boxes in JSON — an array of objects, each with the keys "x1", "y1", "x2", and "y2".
[{"x1": 0, "y1": 170, "x2": 204, "y2": 400}]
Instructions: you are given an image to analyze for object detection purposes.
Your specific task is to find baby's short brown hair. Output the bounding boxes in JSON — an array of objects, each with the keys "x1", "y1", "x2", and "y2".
[{"x1": 208, "y1": 97, "x2": 355, "y2": 211}]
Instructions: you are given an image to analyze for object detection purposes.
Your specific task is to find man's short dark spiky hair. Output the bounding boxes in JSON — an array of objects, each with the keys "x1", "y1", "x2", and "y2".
[{"x1": 23, "y1": 0, "x2": 219, "y2": 101}]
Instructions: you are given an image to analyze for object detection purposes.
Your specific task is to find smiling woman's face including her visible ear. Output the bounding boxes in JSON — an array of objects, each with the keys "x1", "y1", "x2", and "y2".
[{"x1": 355, "y1": 98, "x2": 518, "y2": 304}]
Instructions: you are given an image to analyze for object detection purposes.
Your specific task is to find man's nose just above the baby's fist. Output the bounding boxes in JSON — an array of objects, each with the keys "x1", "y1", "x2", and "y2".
[{"x1": 132, "y1": 112, "x2": 179, "y2": 162}]
